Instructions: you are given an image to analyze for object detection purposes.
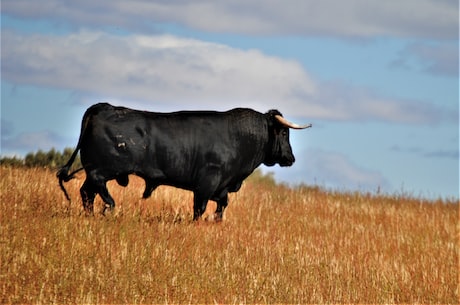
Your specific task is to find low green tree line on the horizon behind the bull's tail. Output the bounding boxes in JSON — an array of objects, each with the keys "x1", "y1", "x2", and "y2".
[{"x1": 0, "y1": 147, "x2": 81, "y2": 169}]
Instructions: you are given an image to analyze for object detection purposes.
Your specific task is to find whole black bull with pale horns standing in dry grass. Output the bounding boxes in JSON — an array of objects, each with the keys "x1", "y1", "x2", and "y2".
[{"x1": 57, "y1": 103, "x2": 311, "y2": 220}]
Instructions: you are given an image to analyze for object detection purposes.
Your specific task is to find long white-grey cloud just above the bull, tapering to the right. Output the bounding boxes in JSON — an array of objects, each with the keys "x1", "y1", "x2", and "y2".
[{"x1": 2, "y1": 31, "x2": 452, "y2": 123}]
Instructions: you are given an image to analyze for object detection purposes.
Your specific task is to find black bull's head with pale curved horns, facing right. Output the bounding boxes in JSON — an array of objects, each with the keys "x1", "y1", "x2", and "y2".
[{"x1": 264, "y1": 110, "x2": 312, "y2": 166}]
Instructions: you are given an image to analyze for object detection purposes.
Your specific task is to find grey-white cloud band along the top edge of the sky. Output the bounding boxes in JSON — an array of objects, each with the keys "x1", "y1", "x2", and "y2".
[{"x1": 2, "y1": 0, "x2": 458, "y2": 39}]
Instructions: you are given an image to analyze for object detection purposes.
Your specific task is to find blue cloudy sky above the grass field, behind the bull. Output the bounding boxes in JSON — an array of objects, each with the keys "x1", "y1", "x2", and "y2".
[{"x1": 1, "y1": 0, "x2": 459, "y2": 198}]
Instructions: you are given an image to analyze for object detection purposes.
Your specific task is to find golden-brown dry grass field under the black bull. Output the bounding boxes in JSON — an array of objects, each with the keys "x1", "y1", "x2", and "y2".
[{"x1": 0, "y1": 167, "x2": 459, "y2": 304}]
